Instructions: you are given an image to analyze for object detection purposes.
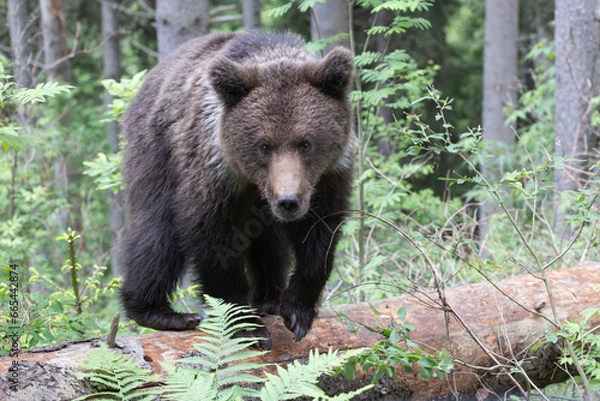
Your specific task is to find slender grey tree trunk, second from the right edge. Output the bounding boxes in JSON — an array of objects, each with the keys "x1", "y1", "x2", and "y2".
[{"x1": 479, "y1": 0, "x2": 519, "y2": 244}]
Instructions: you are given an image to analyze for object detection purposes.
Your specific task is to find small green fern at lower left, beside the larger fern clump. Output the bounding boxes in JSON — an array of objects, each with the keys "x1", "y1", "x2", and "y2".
[{"x1": 73, "y1": 343, "x2": 158, "y2": 401}]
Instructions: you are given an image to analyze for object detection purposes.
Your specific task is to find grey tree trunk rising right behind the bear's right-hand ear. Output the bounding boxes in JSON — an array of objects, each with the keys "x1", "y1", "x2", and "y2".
[{"x1": 310, "y1": 0, "x2": 350, "y2": 53}]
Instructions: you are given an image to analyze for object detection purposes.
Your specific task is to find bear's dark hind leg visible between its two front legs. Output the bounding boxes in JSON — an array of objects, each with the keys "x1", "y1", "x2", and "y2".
[{"x1": 246, "y1": 222, "x2": 290, "y2": 315}]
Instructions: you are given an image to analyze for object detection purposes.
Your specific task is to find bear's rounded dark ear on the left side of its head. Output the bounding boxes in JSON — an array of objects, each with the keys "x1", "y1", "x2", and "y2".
[{"x1": 209, "y1": 57, "x2": 258, "y2": 107}]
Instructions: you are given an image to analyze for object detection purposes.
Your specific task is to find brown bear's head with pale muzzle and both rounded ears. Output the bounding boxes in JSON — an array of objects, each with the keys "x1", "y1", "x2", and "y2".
[{"x1": 210, "y1": 47, "x2": 354, "y2": 221}]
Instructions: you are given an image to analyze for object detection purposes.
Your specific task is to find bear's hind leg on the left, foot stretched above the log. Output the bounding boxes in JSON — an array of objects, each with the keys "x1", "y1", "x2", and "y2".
[{"x1": 121, "y1": 216, "x2": 202, "y2": 330}]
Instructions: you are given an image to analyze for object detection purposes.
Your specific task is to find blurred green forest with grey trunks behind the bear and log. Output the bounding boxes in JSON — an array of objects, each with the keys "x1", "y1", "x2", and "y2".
[{"x1": 0, "y1": 0, "x2": 600, "y2": 396}]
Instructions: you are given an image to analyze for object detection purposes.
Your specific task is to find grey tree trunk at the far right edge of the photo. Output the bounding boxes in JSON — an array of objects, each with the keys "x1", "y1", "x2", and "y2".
[{"x1": 554, "y1": 0, "x2": 600, "y2": 240}]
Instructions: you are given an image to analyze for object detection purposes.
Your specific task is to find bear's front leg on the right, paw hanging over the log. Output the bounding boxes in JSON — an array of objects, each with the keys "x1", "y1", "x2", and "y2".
[{"x1": 280, "y1": 216, "x2": 341, "y2": 341}]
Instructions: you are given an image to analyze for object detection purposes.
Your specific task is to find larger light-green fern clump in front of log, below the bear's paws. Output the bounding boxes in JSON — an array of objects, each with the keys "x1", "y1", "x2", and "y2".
[{"x1": 163, "y1": 296, "x2": 369, "y2": 401}]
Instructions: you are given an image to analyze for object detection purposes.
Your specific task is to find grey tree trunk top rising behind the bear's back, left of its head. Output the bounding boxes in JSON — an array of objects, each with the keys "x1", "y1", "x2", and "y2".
[{"x1": 156, "y1": 0, "x2": 210, "y2": 60}]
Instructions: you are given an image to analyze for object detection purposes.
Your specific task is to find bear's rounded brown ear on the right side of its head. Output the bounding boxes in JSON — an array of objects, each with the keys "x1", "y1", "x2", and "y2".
[{"x1": 306, "y1": 46, "x2": 354, "y2": 99}]
